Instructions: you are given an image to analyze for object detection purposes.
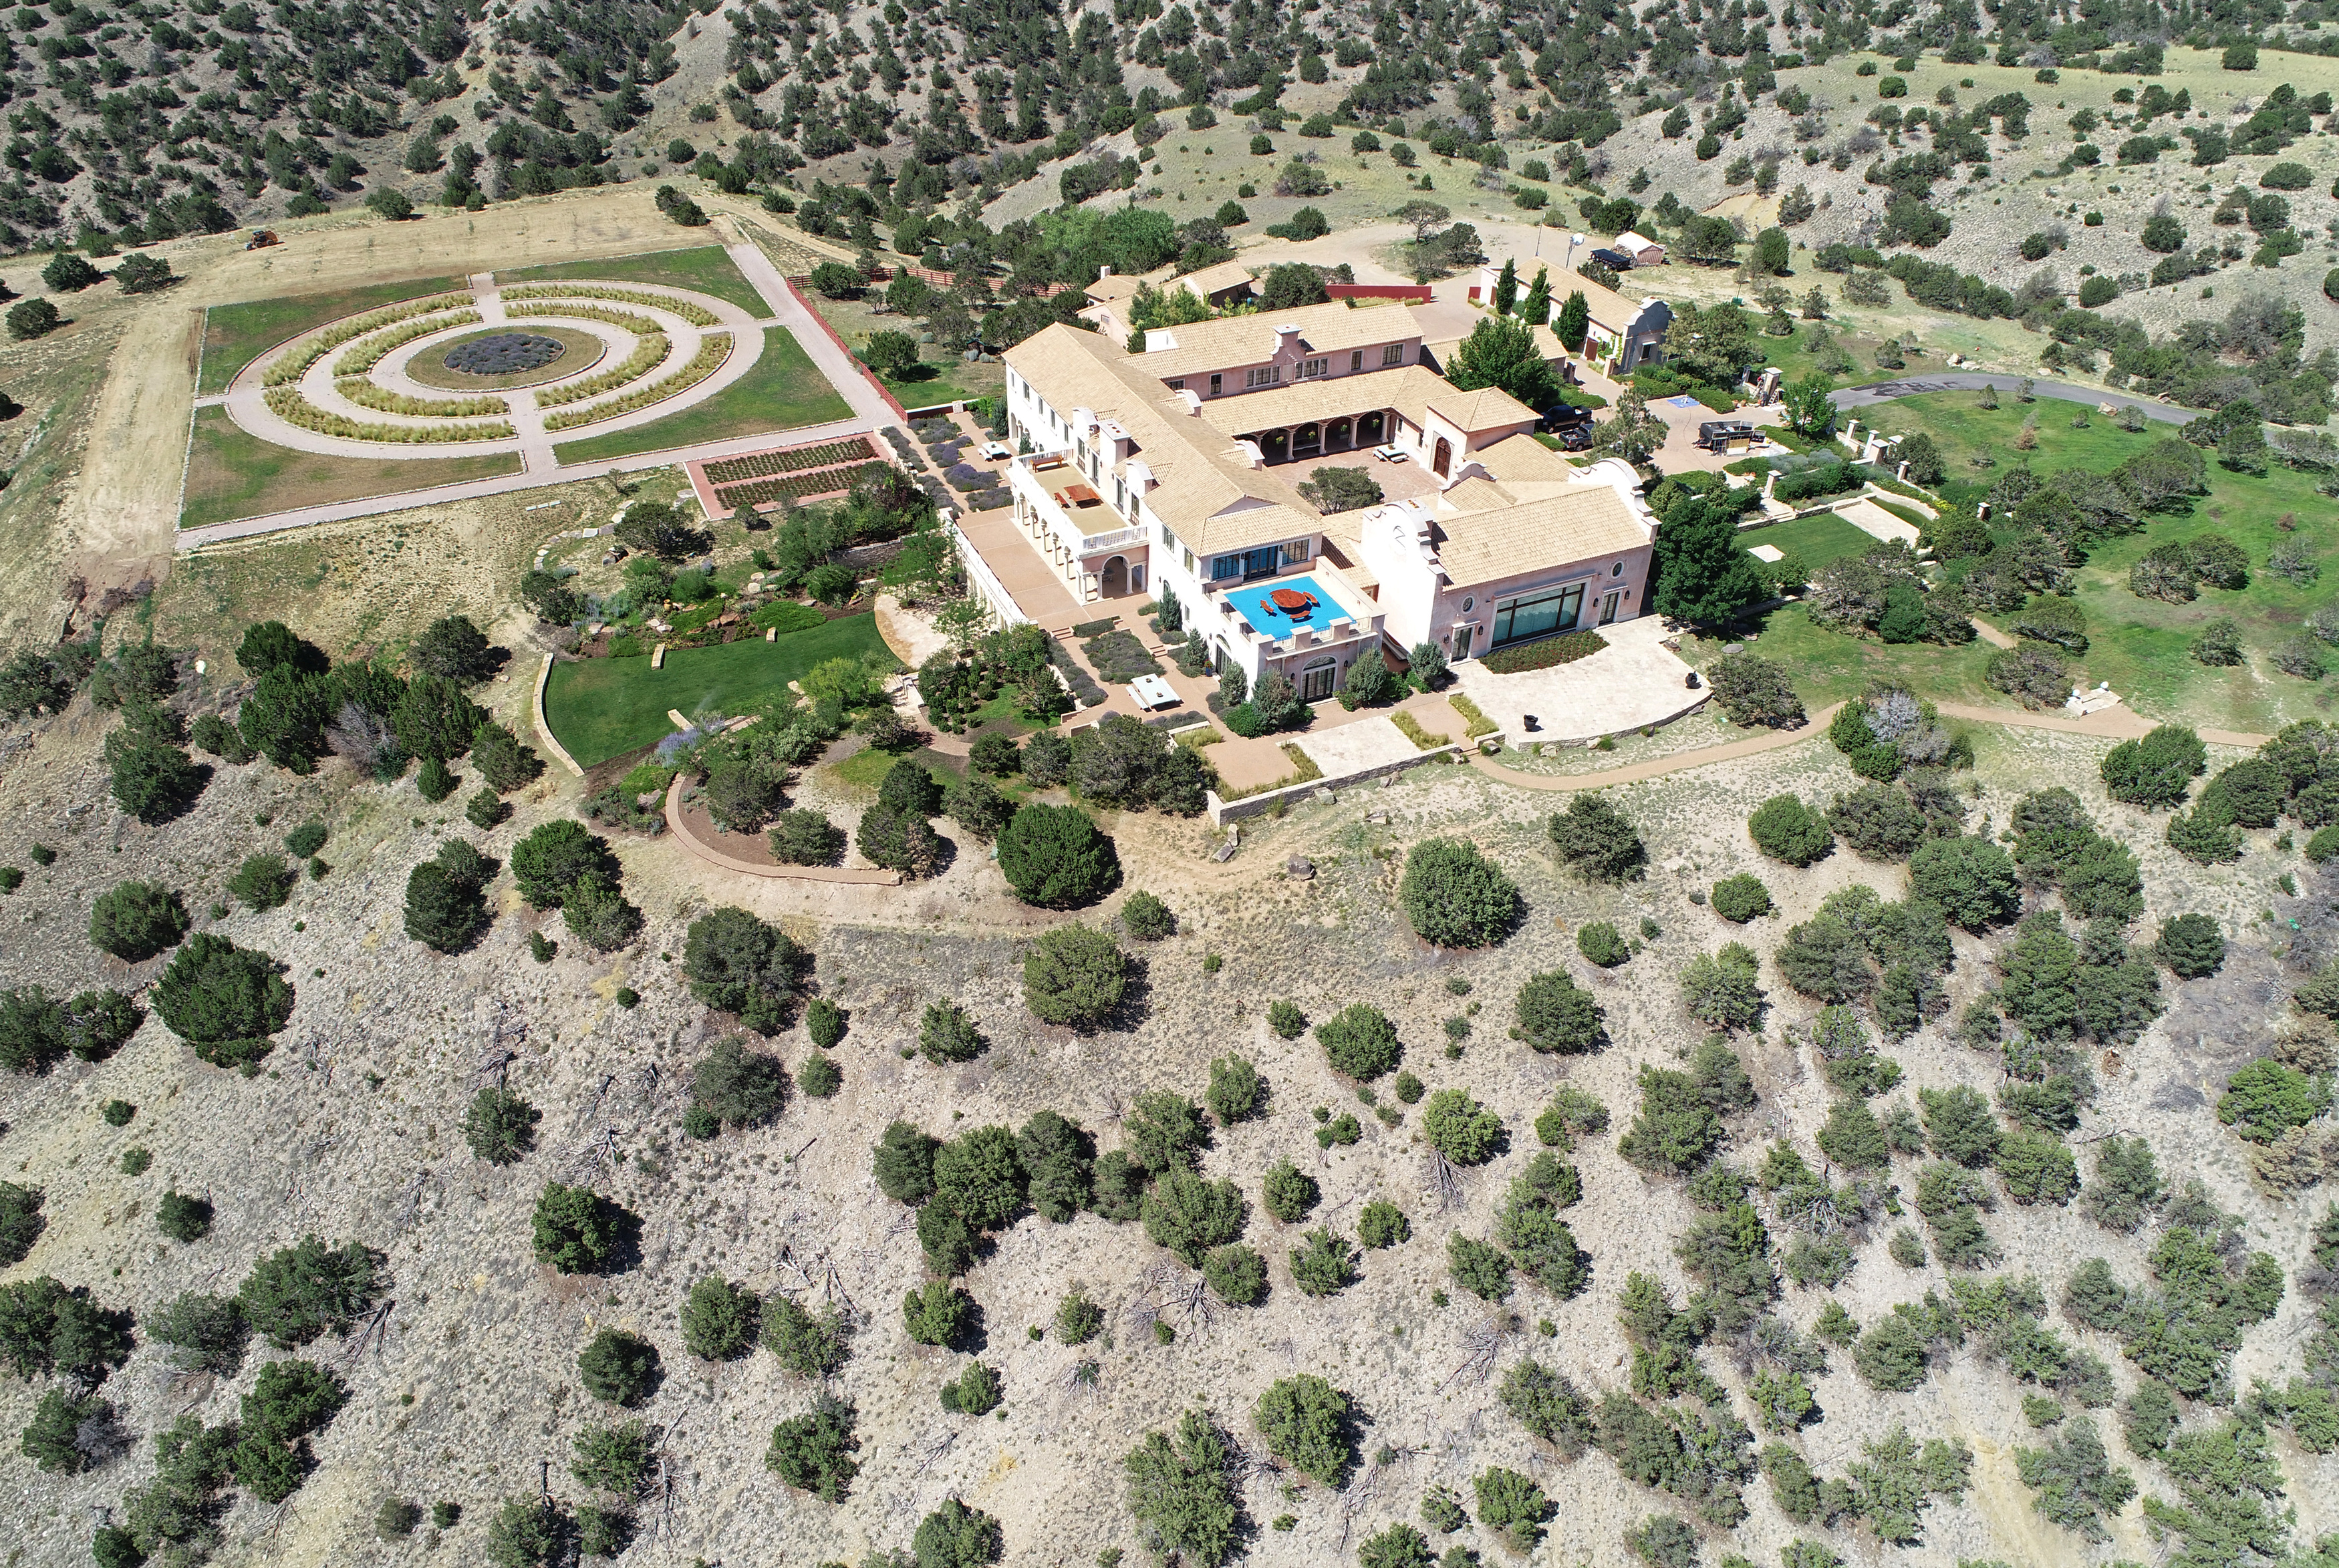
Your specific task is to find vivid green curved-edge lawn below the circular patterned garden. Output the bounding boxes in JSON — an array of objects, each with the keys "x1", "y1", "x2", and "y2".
[{"x1": 545, "y1": 615, "x2": 891, "y2": 766}]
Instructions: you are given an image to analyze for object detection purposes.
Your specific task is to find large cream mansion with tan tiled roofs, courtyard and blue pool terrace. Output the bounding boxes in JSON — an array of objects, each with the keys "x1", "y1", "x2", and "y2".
[{"x1": 987, "y1": 304, "x2": 1656, "y2": 699}]
